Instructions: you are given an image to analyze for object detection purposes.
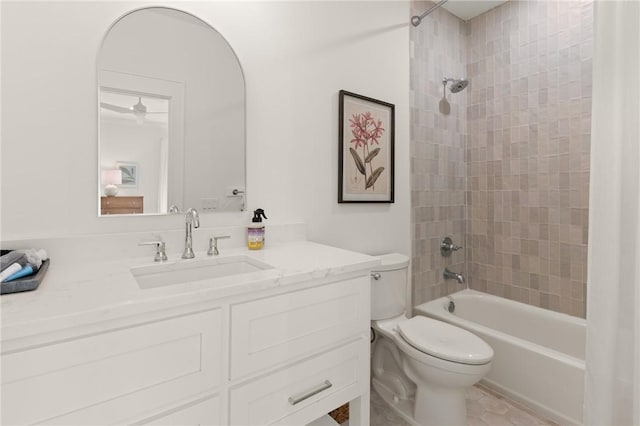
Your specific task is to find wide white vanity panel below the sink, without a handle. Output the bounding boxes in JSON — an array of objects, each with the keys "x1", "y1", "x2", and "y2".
[{"x1": 2, "y1": 309, "x2": 222, "y2": 424}]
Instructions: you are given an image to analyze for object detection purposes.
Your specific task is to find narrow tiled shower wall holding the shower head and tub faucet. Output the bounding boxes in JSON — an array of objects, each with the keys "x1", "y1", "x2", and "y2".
[{"x1": 410, "y1": 1, "x2": 467, "y2": 305}]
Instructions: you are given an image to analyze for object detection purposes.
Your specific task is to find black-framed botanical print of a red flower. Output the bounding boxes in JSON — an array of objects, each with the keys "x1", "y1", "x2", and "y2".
[{"x1": 338, "y1": 90, "x2": 395, "y2": 203}]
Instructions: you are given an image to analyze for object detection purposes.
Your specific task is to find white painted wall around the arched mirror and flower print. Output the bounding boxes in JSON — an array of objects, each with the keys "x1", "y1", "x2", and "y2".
[{"x1": 1, "y1": 1, "x2": 409, "y2": 253}]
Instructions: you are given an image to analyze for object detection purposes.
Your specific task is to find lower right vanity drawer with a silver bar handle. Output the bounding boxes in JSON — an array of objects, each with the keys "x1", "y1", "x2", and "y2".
[{"x1": 229, "y1": 338, "x2": 369, "y2": 426}]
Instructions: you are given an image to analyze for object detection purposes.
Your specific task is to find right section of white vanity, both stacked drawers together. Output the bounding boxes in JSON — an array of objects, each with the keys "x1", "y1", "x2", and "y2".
[{"x1": 229, "y1": 275, "x2": 370, "y2": 426}]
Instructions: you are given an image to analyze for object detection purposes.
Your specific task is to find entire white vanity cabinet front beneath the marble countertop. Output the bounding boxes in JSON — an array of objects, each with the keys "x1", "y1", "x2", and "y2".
[{"x1": 1, "y1": 270, "x2": 370, "y2": 426}]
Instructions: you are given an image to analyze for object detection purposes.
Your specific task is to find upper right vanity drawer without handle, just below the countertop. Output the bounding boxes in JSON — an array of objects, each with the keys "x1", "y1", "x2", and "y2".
[{"x1": 231, "y1": 276, "x2": 370, "y2": 379}]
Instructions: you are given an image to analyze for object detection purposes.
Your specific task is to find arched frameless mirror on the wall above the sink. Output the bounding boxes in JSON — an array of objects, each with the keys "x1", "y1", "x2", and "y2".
[{"x1": 97, "y1": 7, "x2": 246, "y2": 215}]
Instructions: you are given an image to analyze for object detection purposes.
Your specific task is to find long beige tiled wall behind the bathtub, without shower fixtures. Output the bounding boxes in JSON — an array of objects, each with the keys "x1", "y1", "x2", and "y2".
[{"x1": 466, "y1": 0, "x2": 593, "y2": 317}]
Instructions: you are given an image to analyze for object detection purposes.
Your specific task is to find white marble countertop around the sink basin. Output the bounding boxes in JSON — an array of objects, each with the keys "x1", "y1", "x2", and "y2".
[{"x1": 0, "y1": 241, "x2": 380, "y2": 342}]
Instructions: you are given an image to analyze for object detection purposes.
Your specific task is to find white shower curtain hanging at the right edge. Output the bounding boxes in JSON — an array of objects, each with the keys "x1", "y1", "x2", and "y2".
[{"x1": 584, "y1": 0, "x2": 640, "y2": 426}]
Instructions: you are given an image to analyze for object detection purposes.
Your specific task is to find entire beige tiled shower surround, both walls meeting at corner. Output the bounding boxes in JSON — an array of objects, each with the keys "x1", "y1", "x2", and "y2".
[{"x1": 411, "y1": 0, "x2": 593, "y2": 316}]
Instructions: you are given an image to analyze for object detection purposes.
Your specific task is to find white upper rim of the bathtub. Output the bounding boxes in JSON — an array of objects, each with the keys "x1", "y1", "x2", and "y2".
[{"x1": 414, "y1": 289, "x2": 585, "y2": 370}]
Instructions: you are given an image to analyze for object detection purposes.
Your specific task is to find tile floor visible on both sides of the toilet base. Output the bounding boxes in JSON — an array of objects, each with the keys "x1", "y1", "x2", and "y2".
[{"x1": 371, "y1": 385, "x2": 557, "y2": 426}]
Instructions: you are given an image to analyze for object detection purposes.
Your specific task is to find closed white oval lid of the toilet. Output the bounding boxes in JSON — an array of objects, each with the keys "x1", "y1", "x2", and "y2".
[{"x1": 398, "y1": 316, "x2": 493, "y2": 364}]
